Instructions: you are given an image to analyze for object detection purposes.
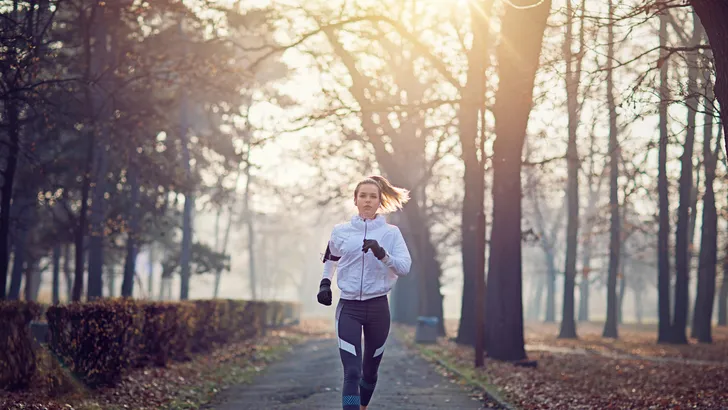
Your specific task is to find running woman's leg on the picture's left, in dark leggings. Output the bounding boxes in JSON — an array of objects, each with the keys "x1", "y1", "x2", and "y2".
[{"x1": 336, "y1": 301, "x2": 362, "y2": 410}]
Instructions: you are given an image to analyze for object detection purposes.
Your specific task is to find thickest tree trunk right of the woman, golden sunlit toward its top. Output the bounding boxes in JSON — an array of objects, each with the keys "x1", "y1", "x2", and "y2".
[{"x1": 486, "y1": 0, "x2": 551, "y2": 360}]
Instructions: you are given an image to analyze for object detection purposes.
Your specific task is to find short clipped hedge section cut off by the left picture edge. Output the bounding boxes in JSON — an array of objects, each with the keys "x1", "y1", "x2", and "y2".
[{"x1": 0, "y1": 301, "x2": 41, "y2": 390}]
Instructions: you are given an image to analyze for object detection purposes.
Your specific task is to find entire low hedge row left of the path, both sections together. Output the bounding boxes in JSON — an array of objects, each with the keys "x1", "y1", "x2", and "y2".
[{"x1": 0, "y1": 299, "x2": 299, "y2": 388}]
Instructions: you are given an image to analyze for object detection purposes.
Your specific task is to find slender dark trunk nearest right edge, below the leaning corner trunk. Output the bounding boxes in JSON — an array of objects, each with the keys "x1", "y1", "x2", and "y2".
[{"x1": 692, "y1": 60, "x2": 720, "y2": 343}]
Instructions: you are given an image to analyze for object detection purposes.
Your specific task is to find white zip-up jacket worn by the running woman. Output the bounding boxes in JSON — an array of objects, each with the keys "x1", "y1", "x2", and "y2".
[{"x1": 323, "y1": 215, "x2": 412, "y2": 300}]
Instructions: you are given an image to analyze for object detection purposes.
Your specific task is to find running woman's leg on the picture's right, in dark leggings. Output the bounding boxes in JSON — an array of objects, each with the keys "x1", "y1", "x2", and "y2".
[{"x1": 359, "y1": 298, "x2": 390, "y2": 408}]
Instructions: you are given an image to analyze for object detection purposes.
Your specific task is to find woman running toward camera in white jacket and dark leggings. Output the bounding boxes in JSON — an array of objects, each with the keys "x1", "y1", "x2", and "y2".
[{"x1": 317, "y1": 175, "x2": 412, "y2": 410}]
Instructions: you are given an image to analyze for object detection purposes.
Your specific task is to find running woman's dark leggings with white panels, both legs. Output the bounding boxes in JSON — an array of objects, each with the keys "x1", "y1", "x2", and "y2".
[{"x1": 336, "y1": 295, "x2": 389, "y2": 410}]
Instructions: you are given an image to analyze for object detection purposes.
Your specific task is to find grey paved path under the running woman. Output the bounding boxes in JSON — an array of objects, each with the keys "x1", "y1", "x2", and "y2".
[{"x1": 206, "y1": 335, "x2": 498, "y2": 410}]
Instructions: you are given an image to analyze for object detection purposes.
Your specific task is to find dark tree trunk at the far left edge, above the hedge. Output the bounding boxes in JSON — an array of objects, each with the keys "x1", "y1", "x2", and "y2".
[{"x1": 0, "y1": 94, "x2": 20, "y2": 300}]
